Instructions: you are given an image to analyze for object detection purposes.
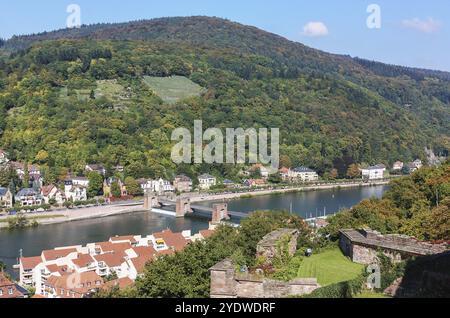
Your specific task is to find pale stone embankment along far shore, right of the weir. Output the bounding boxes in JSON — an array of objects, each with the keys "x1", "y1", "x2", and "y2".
[{"x1": 189, "y1": 180, "x2": 390, "y2": 203}]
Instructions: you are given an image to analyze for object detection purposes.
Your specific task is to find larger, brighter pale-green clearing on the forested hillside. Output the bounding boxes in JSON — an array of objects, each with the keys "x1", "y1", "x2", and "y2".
[{"x1": 144, "y1": 76, "x2": 205, "y2": 104}]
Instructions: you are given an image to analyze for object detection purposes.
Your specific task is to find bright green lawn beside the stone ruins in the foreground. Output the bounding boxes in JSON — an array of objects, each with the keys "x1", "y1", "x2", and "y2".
[{"x1": 297, "y1": 248, "x2": 364, "y2": 286}]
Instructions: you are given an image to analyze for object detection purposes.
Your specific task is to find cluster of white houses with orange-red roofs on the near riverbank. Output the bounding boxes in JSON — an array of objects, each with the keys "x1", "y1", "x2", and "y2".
[{"x1": 19, "y1": 228, "x2": 214, "y2": 298}]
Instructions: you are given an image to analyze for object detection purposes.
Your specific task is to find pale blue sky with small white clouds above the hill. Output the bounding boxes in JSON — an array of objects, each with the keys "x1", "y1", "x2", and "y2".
[{"x1": 0, "y1": 0, "x2": 450, "y2": 71}]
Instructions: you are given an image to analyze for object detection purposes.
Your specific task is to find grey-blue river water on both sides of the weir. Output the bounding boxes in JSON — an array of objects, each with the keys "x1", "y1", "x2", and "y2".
[{"x1": 0, "y1": 186, "x2": 387, "y2": 277}]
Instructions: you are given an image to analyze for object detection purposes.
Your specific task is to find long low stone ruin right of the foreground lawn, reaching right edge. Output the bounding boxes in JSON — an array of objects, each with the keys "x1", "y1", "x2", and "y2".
[{"x1": 339, "y1": 229, "x2": 447, "y2": 265}]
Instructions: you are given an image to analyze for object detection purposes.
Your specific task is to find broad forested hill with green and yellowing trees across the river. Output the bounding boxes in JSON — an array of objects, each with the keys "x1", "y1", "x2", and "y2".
[{"x1": 0, "y1": 17, "x2": 450, "y2": 181}]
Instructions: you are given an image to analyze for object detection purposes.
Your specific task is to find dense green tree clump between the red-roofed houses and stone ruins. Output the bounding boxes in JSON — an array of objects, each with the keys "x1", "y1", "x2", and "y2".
[{"x1": 128, "y1": 212, "x2": 310, "y2": 298}]
